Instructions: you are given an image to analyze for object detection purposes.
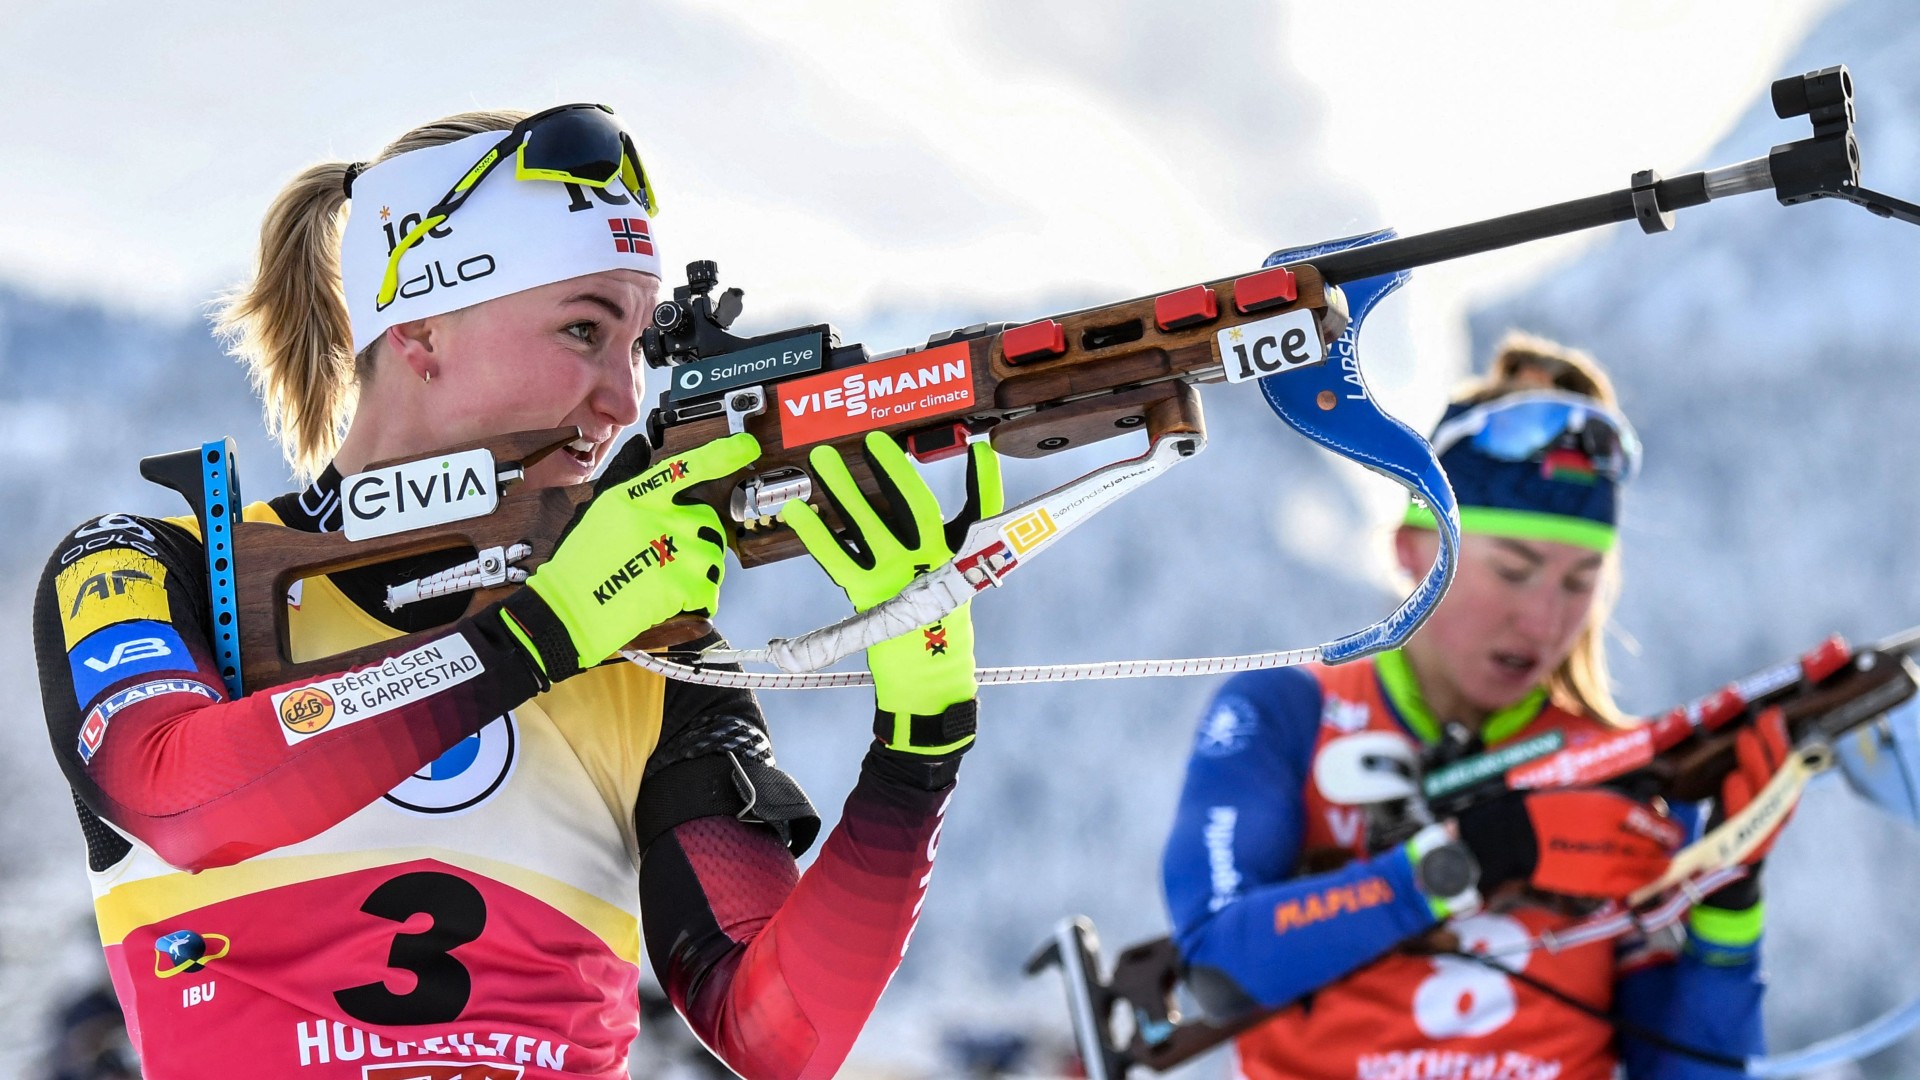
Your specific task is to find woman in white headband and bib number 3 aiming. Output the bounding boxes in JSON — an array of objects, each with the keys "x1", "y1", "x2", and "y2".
[{"x1": 33, "y1": 106, "x2": 998, "y2": 1080}]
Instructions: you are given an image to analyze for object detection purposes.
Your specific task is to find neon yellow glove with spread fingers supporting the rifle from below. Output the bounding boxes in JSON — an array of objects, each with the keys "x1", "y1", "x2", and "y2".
[{"x1": 781, "y1": 430, "x2": 1004, "y2": 755}]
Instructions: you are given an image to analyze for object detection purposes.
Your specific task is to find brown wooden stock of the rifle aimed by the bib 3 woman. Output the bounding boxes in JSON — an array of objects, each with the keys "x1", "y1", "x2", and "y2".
[{"x1": 198, "y1": 249, "x2": 1320, "y2": 688}]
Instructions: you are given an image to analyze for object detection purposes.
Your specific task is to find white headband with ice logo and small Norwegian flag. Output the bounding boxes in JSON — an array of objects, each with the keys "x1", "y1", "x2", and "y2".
[{"x1": 340, "y1": 131, "x2": 660, "y2": 354}]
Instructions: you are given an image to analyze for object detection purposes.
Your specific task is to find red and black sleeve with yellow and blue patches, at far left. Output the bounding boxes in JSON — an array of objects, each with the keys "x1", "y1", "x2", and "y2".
[{"x1": 33, "y1": 515, "x2": 538, "y2": 871}]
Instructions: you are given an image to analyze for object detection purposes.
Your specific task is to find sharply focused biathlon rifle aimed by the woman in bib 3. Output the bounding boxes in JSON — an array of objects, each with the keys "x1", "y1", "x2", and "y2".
[{"x1": 142, "y1": 67, "x2": 1920, "y2": 694}]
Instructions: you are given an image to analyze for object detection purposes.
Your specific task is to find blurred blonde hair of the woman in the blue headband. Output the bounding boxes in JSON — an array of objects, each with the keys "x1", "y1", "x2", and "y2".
[{"x1": 1453, "y1": 331, "x2": 1626, "y2": 726}]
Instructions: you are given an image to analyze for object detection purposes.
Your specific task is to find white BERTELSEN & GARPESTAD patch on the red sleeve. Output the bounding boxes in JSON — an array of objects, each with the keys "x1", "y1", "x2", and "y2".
[{"x1": 273, "y1": 634, "x2": 486, "y2": 746}]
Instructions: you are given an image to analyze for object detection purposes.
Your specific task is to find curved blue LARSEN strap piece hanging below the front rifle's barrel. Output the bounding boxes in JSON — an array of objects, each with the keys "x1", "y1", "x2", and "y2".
[{"x1": 1260, "y1": 229, "x2": 1459, "y2": 663}]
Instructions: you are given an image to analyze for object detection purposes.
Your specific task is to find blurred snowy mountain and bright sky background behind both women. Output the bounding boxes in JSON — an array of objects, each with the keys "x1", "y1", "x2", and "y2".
[{"x1": 0, "y1": 0, "x2": 1920, "y2": 1076}]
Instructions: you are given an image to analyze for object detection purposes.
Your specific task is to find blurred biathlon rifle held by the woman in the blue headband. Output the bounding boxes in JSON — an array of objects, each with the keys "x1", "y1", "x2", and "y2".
[{"x1": 1027, "y1": 628, "x2": 1920, "y2": 1080}]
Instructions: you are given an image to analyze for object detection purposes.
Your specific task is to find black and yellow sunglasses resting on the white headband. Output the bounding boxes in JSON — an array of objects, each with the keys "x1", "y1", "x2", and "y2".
[{"x1": 378, "y1": 104, "x2": 660, "y2": 307}]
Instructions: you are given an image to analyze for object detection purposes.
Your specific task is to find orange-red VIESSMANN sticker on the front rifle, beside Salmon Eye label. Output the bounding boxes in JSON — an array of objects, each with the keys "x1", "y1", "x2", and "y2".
[{"x1": 780, "y1": 342, "x2": 973, "y2": 450}]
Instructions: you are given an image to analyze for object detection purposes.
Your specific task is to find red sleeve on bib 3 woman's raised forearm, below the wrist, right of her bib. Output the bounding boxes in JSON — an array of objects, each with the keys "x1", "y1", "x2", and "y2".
[{"x1": 641, "y1": 757, "x2": 952, "y2": 1080}]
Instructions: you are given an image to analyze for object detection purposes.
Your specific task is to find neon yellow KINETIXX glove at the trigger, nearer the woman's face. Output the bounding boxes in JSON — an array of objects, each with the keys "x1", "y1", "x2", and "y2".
[{"x1": 501, "y1": 432, "x2": 760, "y2": 682}]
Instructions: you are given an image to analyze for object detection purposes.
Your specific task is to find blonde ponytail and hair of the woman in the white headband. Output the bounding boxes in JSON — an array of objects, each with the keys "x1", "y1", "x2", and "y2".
[{"x1": 213, "y1": 110, "x2": 526, "y2": 480}]
